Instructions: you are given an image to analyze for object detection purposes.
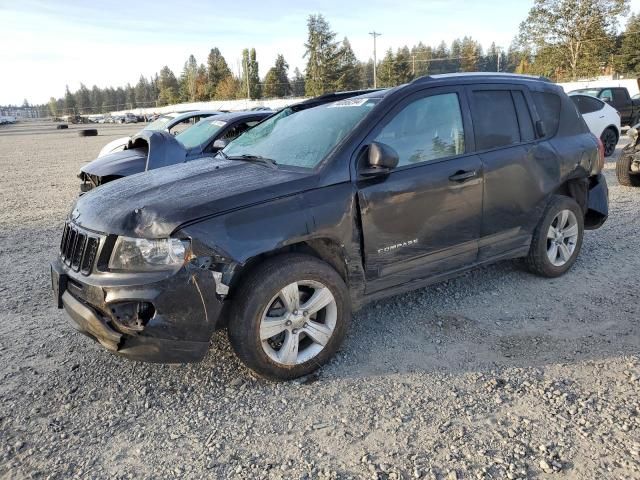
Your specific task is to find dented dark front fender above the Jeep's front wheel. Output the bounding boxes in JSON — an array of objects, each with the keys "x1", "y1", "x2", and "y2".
[{"x1": 174, "y1": 183, "x2": 364, "y2": 301}]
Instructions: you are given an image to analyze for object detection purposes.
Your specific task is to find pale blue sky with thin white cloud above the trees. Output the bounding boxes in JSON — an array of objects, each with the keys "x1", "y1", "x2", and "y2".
[{"x1": 0, "y1": 0, "x2": 640, "y2": 105}]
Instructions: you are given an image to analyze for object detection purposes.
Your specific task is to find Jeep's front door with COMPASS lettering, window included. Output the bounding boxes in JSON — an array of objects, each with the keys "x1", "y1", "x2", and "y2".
[{"x1": 357, "y1": 88, "x2": 483, "y2": 293}]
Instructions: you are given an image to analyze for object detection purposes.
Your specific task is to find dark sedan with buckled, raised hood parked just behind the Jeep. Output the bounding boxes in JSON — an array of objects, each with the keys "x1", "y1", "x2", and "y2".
[{"x1": 78, "y1": 112, "x2": 272, "y2": 192}]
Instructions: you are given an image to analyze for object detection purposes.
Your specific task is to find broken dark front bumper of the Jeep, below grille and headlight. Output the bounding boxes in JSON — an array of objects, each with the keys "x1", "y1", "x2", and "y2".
[{"x1": 51, "y1": 259, "x2": 222, "y2": 363}]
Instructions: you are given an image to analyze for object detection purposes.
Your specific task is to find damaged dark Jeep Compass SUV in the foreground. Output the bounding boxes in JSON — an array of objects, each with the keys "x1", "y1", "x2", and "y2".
[{"x1": 51, "y1": 74, "x2": 608, "y2": 379}]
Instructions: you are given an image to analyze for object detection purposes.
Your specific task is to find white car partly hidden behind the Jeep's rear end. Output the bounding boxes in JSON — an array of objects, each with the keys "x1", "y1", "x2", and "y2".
[{"x1": 569, "y1": 93, "x2": 621, "y2": 157}]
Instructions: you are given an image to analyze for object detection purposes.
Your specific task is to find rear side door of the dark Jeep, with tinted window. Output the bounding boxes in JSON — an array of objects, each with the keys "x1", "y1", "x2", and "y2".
[{"x1": 467, "y1": 84, "x2": 552, "y2": 261}]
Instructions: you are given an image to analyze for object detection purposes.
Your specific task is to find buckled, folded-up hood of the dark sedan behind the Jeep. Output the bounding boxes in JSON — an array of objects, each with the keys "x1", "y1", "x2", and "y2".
[{"x1": 81, "y1": 130, "x2": 187, "y2": 177}]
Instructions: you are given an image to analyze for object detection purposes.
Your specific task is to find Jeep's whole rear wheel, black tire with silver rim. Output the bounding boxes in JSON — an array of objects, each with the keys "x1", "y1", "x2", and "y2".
[{"x1": 525, "y1": 195, "x2": 584, "y2": 278}]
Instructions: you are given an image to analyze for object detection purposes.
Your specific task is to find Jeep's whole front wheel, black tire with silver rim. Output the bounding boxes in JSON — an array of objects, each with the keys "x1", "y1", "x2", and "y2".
[{"x1": 228, "y1": 254, "x2": 351, "y2": 380}]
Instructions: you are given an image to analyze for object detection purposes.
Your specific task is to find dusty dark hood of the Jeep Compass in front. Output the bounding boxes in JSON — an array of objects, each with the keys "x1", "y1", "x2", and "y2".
[{"x1": 70, "y1": 158, "x2": 316, "y2": 238}]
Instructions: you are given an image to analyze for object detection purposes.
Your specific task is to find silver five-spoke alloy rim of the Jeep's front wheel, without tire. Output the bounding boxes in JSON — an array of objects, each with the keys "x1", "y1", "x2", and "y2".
[{"x1": 260, "y1": 280, "x2": 338, "y2": 366}]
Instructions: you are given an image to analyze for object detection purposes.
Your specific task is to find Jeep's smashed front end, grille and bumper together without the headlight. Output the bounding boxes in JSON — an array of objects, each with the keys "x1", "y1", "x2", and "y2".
[{"x1": 51, "y1": 222, "x2": 227, "y2": 363}]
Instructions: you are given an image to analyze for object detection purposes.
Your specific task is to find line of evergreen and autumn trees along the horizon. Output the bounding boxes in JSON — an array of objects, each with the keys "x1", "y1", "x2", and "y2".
[{"x1": 48, "y1": 0, "x2": 640, "y2": 116}]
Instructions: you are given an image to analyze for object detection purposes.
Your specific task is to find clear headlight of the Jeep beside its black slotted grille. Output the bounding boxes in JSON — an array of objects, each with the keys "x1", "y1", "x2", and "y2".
[{"x1": 109, "y1": 237, "x2": 189, "y2": 272}]
